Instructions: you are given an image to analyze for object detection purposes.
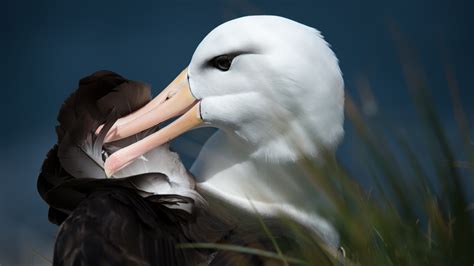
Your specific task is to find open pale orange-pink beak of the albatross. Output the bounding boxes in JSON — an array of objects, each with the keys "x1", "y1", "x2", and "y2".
[{"x1": 103, "y1": 69, "x2": 203, "y2": 177}]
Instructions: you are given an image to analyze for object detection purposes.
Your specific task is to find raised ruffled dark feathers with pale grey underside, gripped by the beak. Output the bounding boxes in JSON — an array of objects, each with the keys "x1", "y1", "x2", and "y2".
[{"x1": 37, "y1": 71, "x2": 199, "y2": 219}]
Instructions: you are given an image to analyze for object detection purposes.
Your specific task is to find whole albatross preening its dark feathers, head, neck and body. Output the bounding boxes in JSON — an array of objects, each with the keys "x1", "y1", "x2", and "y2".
[{"x1": 38, "y1": 16, "x2": 344, "y2": 265}]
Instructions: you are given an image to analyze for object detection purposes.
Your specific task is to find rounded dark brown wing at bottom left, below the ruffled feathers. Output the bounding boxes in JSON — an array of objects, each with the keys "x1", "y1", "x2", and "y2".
[{"x1": 54, "y1": 188, "x2": 210, "y2": 265}]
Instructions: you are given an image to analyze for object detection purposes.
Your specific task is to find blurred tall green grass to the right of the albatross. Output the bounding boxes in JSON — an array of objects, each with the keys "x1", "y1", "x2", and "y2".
[{"x1": 298, "y1": 35, "x2": 474, "y2": 265}]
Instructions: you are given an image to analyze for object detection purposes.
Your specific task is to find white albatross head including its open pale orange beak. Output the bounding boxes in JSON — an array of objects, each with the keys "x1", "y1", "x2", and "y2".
[{"x1": 105, "y1": 16, "x2": 344, "y2": 179}]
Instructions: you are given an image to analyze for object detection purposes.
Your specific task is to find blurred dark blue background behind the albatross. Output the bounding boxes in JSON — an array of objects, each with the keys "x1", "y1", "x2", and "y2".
[{"x1": 0, "y1": 0, "x2": 474, "y2": 265}]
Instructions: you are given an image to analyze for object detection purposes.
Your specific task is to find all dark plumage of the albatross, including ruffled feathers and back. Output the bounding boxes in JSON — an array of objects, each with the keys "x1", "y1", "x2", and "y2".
[{"x1": 37, "y1": 71, "x2": 302, "y2": 265}]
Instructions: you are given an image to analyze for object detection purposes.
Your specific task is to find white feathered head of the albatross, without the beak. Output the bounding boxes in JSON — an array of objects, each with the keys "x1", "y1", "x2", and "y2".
[{"x1": 189, "y1": 16, "x2": 344, "y2": 161}]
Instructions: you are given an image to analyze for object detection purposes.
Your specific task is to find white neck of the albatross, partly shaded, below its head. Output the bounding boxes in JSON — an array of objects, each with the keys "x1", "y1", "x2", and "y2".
[{"x1": 191, "y1": 130, "x2": 338, "y2": 247}]
